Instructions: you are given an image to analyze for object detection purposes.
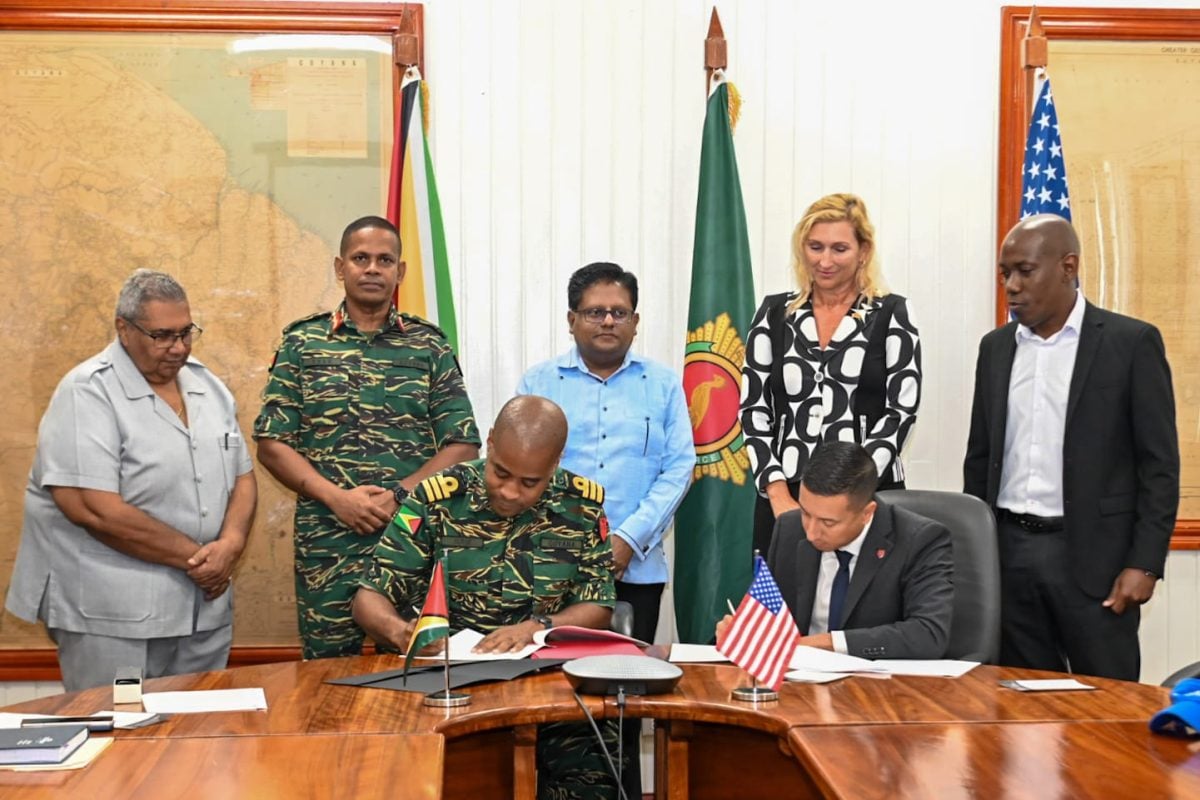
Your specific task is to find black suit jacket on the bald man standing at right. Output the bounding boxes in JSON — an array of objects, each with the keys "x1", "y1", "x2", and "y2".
[{"x1": 962, "y1": 303, "x2": 1180, "y2": 597}]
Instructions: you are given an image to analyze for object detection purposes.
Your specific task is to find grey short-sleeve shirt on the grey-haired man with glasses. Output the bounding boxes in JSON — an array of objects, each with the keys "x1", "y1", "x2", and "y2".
[{"x1": 6, "y1": 341, "x2": 252, "y2": 638}]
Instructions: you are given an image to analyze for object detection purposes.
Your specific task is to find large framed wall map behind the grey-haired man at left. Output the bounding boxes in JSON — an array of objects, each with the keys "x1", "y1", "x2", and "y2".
[{"x1": 0, "y1": 1, "x2": 421, "y2": 678}]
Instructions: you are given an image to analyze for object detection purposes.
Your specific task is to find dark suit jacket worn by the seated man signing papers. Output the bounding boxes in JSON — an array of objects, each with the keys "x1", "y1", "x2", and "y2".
[{"x1": 767, "y1": 500, "x2": 954, "y2": 658}]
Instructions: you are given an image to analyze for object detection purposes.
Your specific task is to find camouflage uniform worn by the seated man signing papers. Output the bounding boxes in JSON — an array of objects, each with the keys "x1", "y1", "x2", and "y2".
[{"x1": 362, "y1": 461, "x2": 629, "y2": 800}]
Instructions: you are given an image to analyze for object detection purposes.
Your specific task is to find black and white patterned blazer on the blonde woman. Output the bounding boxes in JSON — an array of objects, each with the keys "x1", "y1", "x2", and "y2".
[{"x1": 742, "y1": 293, "x2": 920, "y2": 494}]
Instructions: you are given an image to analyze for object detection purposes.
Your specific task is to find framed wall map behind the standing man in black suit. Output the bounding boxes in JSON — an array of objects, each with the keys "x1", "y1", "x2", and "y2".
[{"x1": 996, "y1": 7, "x2": 1200, "y2": 549}]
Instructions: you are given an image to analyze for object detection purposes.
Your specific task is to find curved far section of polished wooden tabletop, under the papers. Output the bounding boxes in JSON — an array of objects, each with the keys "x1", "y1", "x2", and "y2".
[{"x1": 8, "y1": 656, "x2": 1169, "y2": 738}]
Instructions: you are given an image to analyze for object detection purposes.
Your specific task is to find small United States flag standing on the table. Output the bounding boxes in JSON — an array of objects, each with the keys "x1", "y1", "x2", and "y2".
[{"x1": 716, "y1": 555, "x2": 800, "y2": 691}]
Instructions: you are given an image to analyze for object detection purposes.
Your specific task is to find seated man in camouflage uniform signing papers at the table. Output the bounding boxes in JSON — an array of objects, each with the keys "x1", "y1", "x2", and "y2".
[{"x1": 354, "y1": 396, "x2": 618, "y2": 800}]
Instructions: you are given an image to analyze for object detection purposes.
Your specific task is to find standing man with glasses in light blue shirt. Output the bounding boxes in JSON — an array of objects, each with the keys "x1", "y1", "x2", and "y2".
[{"x1": 517, "y1": 261, "x2": 696, "y2": 642}]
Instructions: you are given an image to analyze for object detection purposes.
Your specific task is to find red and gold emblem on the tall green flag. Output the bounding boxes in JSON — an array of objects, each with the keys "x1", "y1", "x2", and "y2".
[{"x1": 683, "y1": 313, "x2": 750, "y2": 486}]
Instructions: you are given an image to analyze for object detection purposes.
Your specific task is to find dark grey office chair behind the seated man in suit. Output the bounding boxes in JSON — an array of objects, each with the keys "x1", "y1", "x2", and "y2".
[{"x1": 878, "y1": 489, "x2": 1000, "y2": 663}]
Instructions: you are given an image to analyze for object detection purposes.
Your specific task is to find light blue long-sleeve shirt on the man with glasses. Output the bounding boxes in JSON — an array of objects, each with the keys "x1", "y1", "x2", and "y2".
[{"x1": 517, "y1": 348, "x2": 696, "y2": 583}]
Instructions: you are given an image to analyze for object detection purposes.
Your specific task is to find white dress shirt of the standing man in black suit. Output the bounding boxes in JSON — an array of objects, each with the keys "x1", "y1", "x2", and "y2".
[{"x1": 996, "y1": 289, "x2": 1085, "y2": 517}]
